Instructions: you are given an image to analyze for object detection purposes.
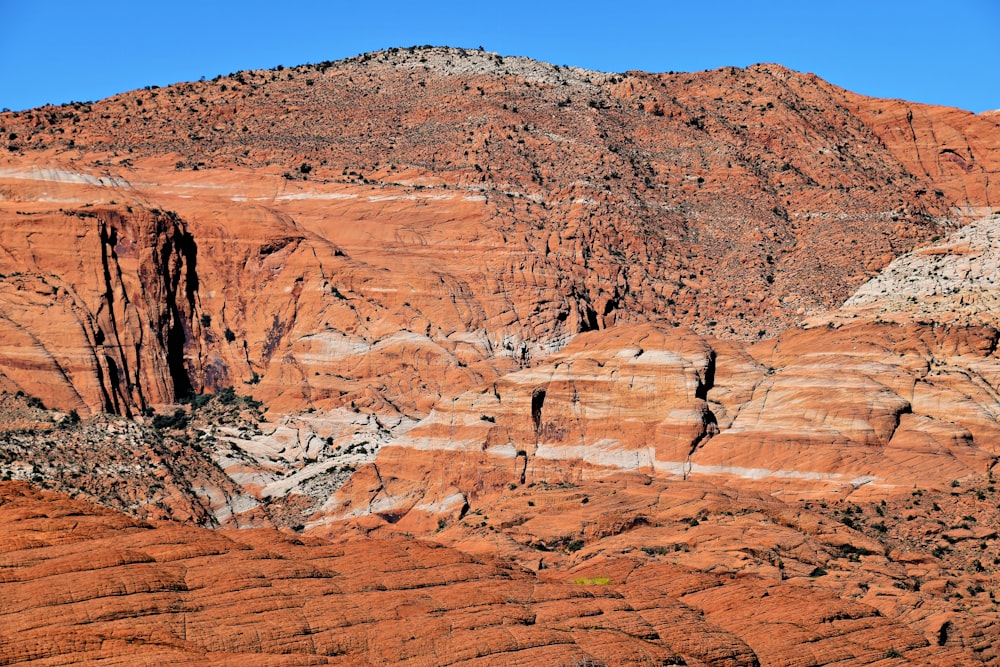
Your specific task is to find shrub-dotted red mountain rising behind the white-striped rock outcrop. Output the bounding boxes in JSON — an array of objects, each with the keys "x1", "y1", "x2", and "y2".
[{"x1": 0, "y1": 49, "x2": 998, "y2": 416}]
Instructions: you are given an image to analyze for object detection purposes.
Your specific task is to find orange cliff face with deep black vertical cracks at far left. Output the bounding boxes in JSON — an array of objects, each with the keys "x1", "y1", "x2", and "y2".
[{"x1": 0, "y1": 208, "x2": 201, "y2": 416}]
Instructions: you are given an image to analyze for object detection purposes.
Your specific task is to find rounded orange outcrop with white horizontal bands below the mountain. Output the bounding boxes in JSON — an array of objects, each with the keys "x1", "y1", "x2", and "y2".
[{"x1": 322, "y1": 322, "x2": 1000, "y2": 527}]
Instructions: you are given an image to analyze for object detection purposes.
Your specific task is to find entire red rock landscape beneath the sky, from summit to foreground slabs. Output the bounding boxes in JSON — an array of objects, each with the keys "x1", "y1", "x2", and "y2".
[{"x1": 0, "y1": 48, "x2": 1000, "y2": 665}]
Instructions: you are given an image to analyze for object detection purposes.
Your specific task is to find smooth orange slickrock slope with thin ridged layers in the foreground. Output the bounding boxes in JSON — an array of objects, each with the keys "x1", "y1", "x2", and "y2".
[{"x1": 0, "y1": 483, "x2": 995, "y2": 667}]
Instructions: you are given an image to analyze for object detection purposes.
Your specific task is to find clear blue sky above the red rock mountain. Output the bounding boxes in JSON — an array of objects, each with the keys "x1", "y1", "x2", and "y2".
[{"x1": 0, "y1": 0, "x2": 1000, "y2": 112}]
